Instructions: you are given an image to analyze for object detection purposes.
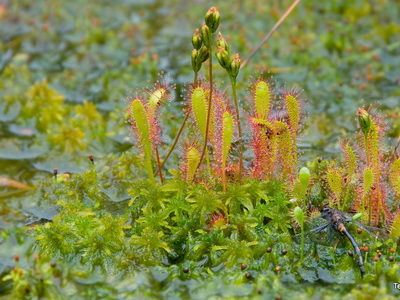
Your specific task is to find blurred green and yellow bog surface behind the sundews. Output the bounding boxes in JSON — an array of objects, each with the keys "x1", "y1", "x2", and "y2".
[{"x1": 0, "y1": 0, "x2": 400, "y2": 188}]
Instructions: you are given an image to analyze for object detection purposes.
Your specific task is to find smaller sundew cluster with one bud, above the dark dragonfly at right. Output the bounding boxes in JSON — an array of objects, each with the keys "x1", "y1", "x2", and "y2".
[{"x1": 327, "y1": 108, "x2": 398, "y2": 225}]
